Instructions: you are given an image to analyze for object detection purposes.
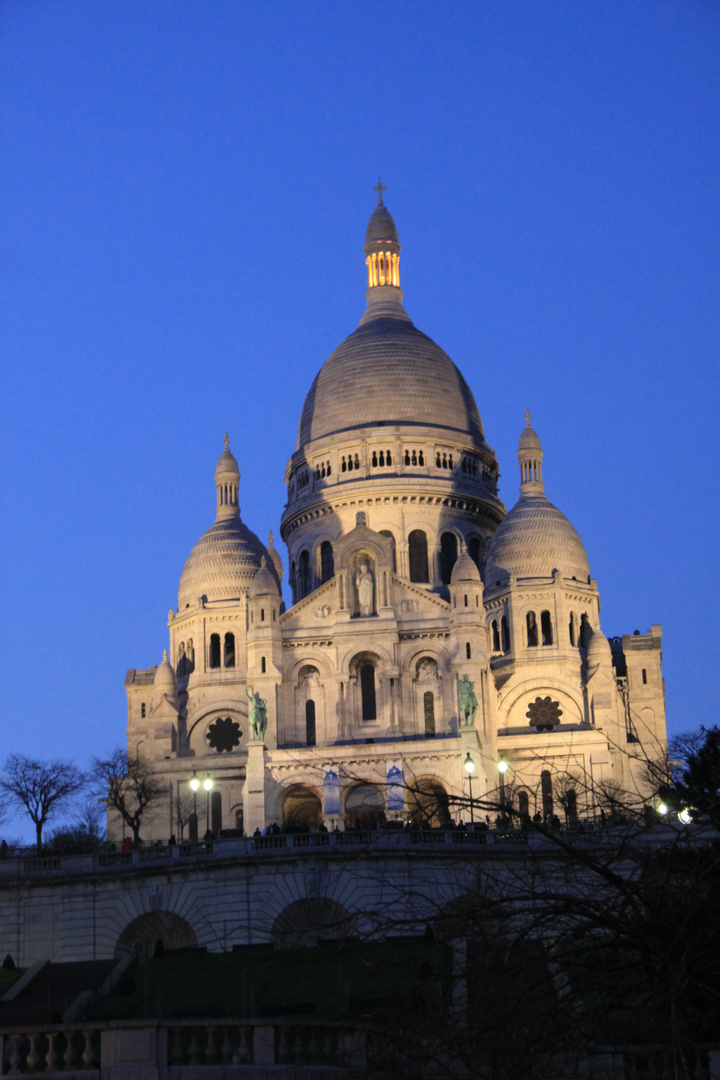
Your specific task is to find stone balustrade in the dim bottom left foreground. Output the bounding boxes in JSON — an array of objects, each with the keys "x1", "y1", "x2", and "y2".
[{"x1": 0, "y1": 1018, "x2": 369, "y2": 1080}]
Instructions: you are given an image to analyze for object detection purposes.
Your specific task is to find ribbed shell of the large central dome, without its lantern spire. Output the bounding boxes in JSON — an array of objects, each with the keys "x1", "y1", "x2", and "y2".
[{"x1": 298, "y1": 319, "x2": 484, "y2": 448}]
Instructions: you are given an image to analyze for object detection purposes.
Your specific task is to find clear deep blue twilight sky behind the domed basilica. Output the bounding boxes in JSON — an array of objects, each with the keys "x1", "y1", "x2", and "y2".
[{"x1": 0, "y1": 0, "x2": 720, "y2": 794}]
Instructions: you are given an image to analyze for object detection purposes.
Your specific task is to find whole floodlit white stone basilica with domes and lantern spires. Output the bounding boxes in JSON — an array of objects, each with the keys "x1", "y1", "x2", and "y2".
[{"x1": 124, "y1": 186, "x2": 665, "y2": 841}]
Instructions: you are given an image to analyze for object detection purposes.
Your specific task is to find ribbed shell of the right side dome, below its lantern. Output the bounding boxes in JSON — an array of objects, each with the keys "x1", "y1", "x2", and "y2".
[{"x1": 485, "y1": 497, "x2": 590, "y2": 585}]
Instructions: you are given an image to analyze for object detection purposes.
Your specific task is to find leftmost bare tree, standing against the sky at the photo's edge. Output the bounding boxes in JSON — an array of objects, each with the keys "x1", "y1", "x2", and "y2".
[{"x1": 0, "y1": 754, "x2": 84, "y2": 852}]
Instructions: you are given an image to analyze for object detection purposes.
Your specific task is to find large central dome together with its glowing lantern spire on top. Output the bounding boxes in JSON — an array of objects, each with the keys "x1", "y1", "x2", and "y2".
[{"x1": 298, "y1": 198, "x2": 485, "y2": 449}]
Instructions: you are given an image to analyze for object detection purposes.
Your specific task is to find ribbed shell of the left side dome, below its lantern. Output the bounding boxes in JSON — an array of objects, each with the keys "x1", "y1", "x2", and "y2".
[{"x1": 178, "y1": 517, "x2": 273, "y2": 610}]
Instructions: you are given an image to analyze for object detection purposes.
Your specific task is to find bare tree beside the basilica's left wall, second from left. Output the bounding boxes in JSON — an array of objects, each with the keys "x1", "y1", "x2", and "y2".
[{"x1": 90, "y1": 747, "x2": 167, "y2": 847}]
